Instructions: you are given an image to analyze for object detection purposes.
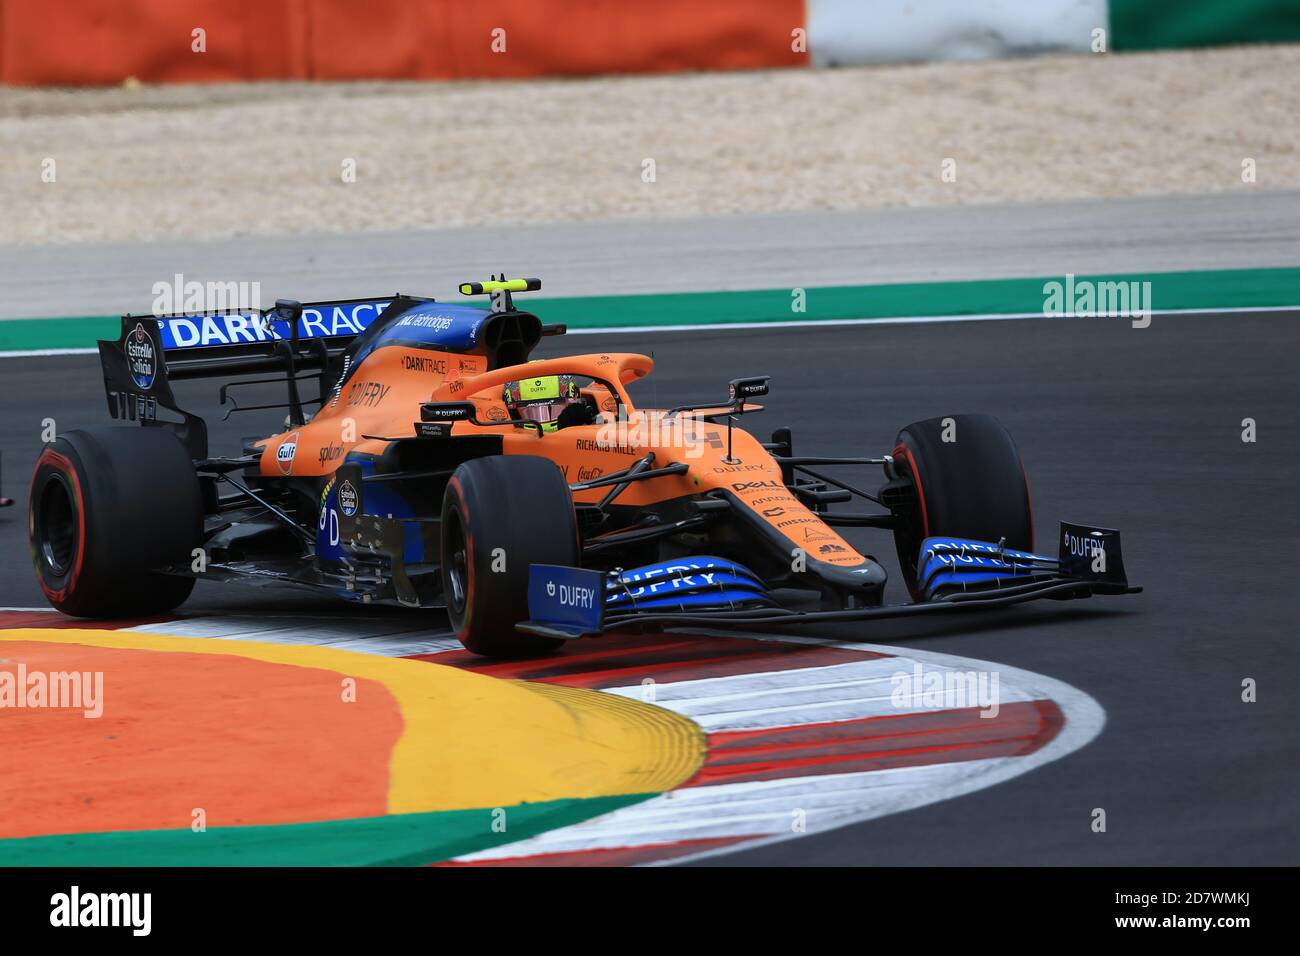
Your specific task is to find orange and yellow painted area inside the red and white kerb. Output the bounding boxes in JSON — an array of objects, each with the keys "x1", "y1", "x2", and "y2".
[{"x1": 0, "y1": 628, "x2": 705, "y2": 838}]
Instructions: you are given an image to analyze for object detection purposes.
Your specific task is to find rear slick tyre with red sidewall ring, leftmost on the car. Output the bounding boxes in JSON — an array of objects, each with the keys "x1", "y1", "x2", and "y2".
[{"x1": 27, "y1": 427, "x2": 203, "y2": 618}]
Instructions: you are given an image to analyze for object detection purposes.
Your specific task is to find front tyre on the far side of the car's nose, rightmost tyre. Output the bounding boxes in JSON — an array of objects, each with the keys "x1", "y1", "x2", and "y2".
[{"x1": 893, "y1": 415, "x2": 1034, "y2": 598}]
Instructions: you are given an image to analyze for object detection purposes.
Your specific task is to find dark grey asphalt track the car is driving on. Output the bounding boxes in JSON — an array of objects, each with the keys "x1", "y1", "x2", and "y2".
[{"x1": 0, "y1": 312, "x2": 1300, "y2": 865}]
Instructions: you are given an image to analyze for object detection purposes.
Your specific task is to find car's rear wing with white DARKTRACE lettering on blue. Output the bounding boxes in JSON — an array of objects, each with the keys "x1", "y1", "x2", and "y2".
[{"x1": 99, "y1": 294, "x2": 421, "y2": 459}]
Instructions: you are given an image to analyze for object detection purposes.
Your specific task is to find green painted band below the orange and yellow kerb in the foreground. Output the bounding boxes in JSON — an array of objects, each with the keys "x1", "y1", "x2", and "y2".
[{"x1": 0, "y1": 793, "x2": 644, "y2": 866}]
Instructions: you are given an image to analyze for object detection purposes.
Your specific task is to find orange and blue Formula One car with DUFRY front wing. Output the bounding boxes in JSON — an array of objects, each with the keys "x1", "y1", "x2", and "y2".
[{"x1": 29, "y1": 276, "x2": 1136, "y2": 656}]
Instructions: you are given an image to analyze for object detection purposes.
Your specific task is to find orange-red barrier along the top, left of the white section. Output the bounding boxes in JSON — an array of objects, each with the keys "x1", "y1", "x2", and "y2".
[{"x1": 0, "y1": 0, "x2": 807, "y2": 86}]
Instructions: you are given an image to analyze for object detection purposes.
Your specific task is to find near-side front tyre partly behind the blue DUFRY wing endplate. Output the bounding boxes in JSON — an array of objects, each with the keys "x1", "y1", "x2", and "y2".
[{"x1": 442, "y1": 455, "x2": 580, "y2": 657}]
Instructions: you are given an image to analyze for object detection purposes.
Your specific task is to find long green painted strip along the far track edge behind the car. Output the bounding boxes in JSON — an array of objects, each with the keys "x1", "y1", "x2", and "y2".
[{"x1": 0, "y1": 268, "x2": 1300, "y2": 351}]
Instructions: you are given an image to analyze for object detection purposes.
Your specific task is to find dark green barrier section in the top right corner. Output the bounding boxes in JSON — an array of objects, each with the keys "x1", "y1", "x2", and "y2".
[{"x1": 1110, "y1": 0, "x2": 1300, "y2": 49}]
